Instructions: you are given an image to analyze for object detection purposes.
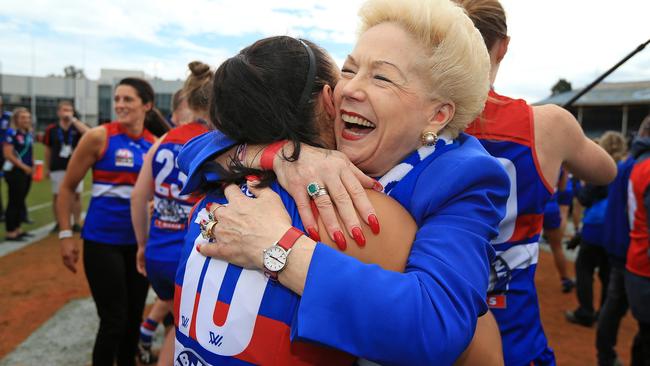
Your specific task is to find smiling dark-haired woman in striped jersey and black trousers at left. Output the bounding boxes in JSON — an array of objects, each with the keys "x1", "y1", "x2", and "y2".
[{"x1": 57, "y1": 78, "x2": 166, "y2": 365}]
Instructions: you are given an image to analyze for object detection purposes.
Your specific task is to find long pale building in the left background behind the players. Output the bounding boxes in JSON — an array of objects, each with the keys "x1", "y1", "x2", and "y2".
[{"x1": 0, "y1": 69, "x2": 183, "y2": 130}]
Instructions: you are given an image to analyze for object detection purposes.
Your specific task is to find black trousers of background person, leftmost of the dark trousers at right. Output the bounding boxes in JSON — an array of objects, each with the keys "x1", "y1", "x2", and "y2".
[{"x1": 575, "y1": 241, "x2": 609, "y2": 319}]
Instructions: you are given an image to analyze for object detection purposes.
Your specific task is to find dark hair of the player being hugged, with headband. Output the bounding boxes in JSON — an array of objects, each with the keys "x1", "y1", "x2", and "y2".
[{"x1": 210, "y1": 36, "x2": 338, "y2": 183}]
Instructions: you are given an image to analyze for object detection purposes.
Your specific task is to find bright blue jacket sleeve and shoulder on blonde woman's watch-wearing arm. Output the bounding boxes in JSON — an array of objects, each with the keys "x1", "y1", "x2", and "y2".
[{"x1": 293, "y1": 135, "x2": 509, "y2": 365}]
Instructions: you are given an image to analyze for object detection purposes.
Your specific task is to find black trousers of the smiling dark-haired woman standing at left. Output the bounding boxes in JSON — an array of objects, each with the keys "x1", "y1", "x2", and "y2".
[{"x1": 83, "y1": 240, "x2": 149, "y2": 366}]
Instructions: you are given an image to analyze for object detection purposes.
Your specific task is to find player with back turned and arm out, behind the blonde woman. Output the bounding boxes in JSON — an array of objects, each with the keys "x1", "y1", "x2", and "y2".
[{"x1": 457, "y1": 0, "x2": 616, "y2": 365}]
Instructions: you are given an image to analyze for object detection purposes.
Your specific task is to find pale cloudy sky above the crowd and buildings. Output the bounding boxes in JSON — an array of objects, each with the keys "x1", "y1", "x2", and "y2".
[{"x1": 0, "y1": 0, "x2": 650, "y2": 102}]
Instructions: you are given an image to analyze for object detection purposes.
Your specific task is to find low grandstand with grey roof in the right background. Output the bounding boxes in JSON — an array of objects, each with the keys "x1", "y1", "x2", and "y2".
[{"x1": 535, "y1": 81, "x2": 650, "y2": 137}]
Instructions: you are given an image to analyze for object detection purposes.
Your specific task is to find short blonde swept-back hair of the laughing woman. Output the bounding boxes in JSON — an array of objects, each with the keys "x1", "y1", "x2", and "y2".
[{"x1": 359, "y1": 0, "x2": 490, "y2": 137}]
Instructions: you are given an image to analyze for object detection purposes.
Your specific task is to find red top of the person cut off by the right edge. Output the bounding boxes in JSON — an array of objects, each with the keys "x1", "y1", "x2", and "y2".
[{"x1": 625, "y1": 153, "x2": 650, "y2": 277}]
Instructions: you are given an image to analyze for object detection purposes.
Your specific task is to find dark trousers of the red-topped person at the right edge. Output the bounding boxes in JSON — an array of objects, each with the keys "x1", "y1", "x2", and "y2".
[{"x1": 625, "y1": 271, "x2": 650, "y2": 366}]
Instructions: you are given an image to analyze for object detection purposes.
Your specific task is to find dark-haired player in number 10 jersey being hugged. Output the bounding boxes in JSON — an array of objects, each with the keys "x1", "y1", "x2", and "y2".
[{"x1": 175, "y1": 33, "x2": 415, "y2": 365}]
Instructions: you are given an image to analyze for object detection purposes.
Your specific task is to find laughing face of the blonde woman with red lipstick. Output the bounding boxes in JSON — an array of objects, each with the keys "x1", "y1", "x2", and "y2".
[{"x1": 334, "y1": 23, "x2": 441, "y2": 176}]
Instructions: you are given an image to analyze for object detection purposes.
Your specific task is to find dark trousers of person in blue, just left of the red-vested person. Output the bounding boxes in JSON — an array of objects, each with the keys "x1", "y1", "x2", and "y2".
[{"x1": 596, "y1": 261, "x2": 628, "y2": 366}]
